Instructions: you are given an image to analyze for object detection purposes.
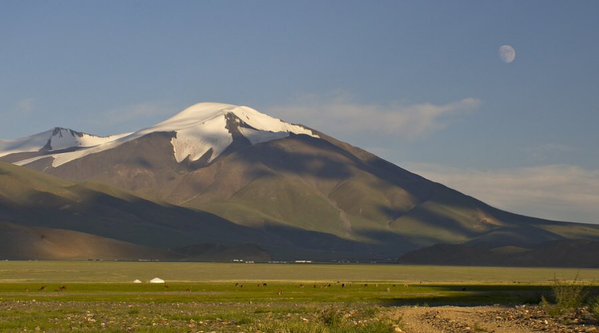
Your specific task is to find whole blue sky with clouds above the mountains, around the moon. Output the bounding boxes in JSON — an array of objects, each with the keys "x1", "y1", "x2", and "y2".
[{"x1": 0, "y1": 0, "x2": 599, "y2": 223}]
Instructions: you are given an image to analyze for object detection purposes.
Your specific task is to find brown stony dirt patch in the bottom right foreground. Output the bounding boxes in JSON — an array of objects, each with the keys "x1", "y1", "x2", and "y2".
[{"x1": 396, "y1": 306, "x2": 599, "y2": 333}]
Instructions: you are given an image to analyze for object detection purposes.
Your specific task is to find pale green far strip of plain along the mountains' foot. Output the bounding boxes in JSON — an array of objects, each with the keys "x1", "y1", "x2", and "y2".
[{"x1": 0, "y1": 261, "x2": 599, "y2": 284}]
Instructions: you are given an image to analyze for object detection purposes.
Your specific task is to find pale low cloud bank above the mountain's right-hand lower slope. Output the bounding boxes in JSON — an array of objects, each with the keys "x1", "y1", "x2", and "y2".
[{"x1": 408, "y1": 163, "x2": 599, "y2": 223}]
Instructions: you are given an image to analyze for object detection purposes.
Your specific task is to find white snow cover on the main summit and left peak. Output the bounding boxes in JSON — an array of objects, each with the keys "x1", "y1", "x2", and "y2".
[{"x1": 0, "y1": 103, "x2": 317, "y2": 167}]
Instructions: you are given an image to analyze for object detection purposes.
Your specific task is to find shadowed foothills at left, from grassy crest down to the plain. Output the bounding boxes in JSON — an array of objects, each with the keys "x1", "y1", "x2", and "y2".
[{"x1": 0, "y1": 162, "x2": 415, "y2": 260}]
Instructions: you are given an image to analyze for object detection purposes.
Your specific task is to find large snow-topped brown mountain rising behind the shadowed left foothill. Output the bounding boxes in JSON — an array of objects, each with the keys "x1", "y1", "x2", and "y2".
[{"x1": 0, "y1": 103, "x2": 599, "y2": 260}]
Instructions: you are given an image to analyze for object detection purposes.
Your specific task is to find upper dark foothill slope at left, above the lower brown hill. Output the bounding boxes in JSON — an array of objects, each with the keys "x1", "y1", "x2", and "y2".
[{"x1": 0, "y1": 163, "x2": 264, "y2": 256}]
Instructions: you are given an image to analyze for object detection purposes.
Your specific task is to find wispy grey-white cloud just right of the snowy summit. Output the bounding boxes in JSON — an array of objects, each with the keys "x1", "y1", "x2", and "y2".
[{"x1": 265, "y1": 94, "x2": 480, "y2": 139}]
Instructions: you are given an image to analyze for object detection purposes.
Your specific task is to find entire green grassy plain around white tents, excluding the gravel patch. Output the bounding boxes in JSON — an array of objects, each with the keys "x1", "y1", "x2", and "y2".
[{"x1": 0, "y1": 262, "x2": 599, "y2": 332}]
